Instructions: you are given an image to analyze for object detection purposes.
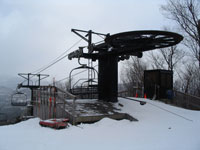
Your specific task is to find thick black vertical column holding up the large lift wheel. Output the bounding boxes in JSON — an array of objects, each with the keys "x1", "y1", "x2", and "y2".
[{"x1": 98, "y1": 56, "x2": 118, "y2": 102}]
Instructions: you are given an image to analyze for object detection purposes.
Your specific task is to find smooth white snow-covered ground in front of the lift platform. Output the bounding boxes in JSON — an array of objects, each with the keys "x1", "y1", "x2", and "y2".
[{"x1": 0, "y1": 99, "x2": 200, "y2": 150}]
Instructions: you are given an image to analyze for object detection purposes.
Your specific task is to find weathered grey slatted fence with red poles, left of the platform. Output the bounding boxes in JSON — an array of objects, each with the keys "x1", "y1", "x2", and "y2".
[{"x1": 34, "y1": 86, "x2": 76, "y2": 124}]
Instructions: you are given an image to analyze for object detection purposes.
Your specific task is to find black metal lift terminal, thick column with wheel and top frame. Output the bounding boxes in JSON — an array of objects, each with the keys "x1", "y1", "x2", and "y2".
[{"x1": 69, "y1": 29, "x2": 183, "y2": 102}]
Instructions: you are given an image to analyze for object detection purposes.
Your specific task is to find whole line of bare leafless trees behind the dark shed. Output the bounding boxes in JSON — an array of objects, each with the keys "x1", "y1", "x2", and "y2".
[{"x1": 121, "y1": 0, "x2": 200, "y2": 97}]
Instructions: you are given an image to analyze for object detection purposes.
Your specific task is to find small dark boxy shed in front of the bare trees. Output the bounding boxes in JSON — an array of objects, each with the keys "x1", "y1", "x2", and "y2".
[{"x1": 144, "y1": 69, "x2": 173, "y2": 99}]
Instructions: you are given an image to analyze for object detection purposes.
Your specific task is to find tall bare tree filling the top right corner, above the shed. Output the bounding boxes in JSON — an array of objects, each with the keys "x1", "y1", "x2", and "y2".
[{"x1": 161, "y1": 0, "x2": 200, "y2": 67}]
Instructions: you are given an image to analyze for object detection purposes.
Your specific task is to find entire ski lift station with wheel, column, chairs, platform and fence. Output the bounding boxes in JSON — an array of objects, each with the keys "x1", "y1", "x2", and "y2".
[{"x1": 11, "y1": 29, "x2": 183, "y2": 124}]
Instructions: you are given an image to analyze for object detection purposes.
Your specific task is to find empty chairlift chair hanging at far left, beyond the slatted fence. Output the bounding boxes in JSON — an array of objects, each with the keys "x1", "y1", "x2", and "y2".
[{"x1": 11, "y1": 91, "x2": 27, "y2": 106}]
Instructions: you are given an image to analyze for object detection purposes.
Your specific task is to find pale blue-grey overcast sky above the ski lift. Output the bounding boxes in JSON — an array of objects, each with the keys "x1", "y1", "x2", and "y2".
[{"x1": 0, "y1": 0, "x2": 173, "y2": 84}]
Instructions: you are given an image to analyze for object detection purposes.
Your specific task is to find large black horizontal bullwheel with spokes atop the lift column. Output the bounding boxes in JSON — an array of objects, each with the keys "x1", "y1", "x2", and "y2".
[{"x1": 105, "y1": 30, "x2": 183, "y2": 54}]
